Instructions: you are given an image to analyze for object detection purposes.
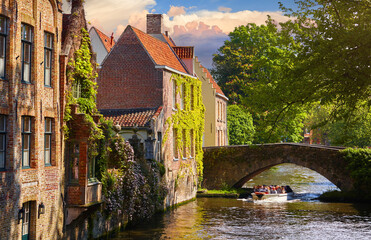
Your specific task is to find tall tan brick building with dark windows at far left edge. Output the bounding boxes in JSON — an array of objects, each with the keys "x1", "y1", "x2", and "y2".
[{"x1": 0, "y1": 0, "x2": 64, "y2": 239}]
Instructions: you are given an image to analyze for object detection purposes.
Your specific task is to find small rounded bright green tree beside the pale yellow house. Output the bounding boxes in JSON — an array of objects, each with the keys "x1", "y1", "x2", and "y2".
[{"x1": 227, "y1": 105, "x2": 255, "y2": 145}]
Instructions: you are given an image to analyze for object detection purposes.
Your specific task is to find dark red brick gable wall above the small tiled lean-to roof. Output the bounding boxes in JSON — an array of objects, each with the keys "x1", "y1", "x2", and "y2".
[{"x1": 97, "y1": 28, "x2": 163, "y2": 109}]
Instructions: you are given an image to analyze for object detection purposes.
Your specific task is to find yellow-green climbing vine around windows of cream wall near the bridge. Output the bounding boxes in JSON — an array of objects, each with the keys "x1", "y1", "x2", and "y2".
[{"x1": 163, "y1": 74, "x2": 205, "y2": 186}]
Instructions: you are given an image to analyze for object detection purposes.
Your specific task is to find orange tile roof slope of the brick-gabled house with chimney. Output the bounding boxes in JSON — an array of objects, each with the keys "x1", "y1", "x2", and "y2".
[{"x1": 129, "y1": 26, "x2": 188, "y2": 74}]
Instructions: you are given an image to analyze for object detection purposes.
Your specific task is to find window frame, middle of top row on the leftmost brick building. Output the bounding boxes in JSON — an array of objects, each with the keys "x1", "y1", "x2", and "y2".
[{"x1": 21, "y1": 23, "x2": 34, "y2": 84}]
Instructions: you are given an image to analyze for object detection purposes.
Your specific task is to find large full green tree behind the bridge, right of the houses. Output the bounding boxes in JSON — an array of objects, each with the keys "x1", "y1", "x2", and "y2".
[{"x1": 212, "y1": 17, "x2": 310, "y2": 143}]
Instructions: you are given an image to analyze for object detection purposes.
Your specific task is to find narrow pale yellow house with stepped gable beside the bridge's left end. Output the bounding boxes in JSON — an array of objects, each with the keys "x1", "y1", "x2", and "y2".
[{"x1": 194, "y1": 58, "x2": 228, "y2": 147}]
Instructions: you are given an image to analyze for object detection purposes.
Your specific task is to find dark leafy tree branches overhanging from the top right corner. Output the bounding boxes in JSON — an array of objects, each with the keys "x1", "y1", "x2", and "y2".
[{"x1": 281, "y1": 0, "x2": 371, "y2": 121}]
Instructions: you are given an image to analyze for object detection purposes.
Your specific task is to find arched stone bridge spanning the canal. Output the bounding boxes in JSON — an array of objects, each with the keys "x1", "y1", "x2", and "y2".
[{"x1": 202, "y1": 143, "x2": 353, "y2": 191}]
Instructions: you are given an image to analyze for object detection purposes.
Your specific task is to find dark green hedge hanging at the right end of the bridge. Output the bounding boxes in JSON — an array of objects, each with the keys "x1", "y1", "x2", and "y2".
[{"x1": 342, "y1": 148, "x2": 371, "y2": 192}]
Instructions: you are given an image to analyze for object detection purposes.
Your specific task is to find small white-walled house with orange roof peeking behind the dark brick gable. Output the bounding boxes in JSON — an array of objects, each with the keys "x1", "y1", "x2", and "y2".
[{"x1": 89, "y1": 27, "x2": 115, "y2": 65}]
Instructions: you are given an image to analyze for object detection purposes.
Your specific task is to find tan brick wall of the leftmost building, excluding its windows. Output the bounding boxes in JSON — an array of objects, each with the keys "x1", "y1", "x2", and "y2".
[{"x1": 0, "y1": 0, "x2": 63, "y2": 239}]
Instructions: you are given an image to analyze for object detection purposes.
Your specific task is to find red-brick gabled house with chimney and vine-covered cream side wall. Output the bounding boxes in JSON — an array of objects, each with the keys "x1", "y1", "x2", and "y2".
[{"x1": 97, "y1": 14, "x2": 203, "y2": 206}]
